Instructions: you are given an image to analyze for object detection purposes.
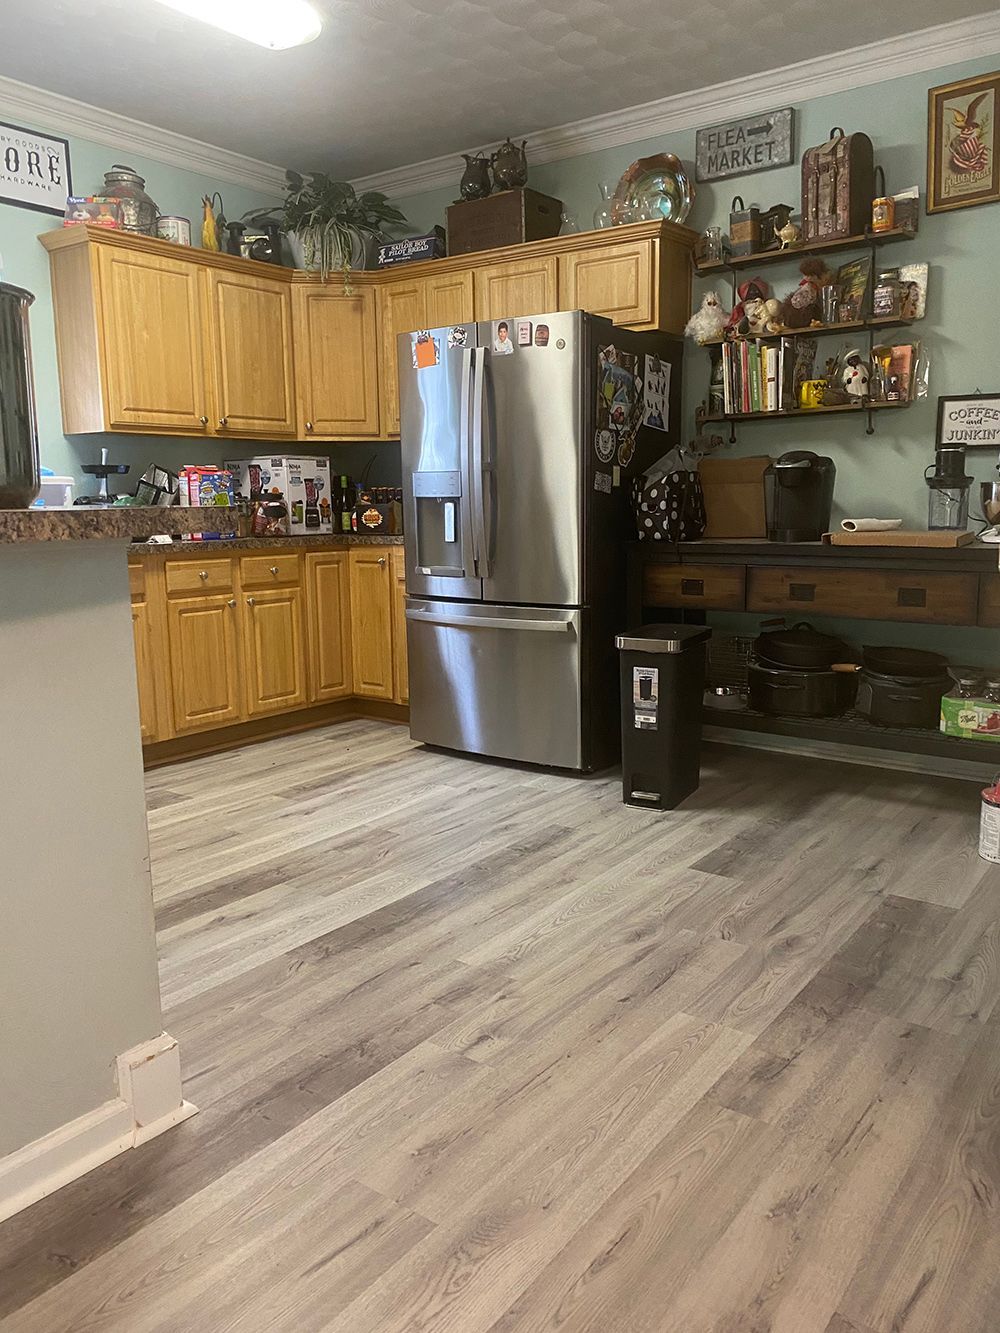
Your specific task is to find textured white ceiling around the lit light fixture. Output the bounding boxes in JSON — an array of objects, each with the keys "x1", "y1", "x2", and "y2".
[{"x1": 0, "y1": 0, "x2": 996, "y2": 177}]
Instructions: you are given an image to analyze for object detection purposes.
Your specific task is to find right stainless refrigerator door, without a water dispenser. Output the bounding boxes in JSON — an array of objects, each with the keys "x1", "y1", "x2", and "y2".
[{"x1": 472, "y1": 311, "x2": 588, "y2": 607}]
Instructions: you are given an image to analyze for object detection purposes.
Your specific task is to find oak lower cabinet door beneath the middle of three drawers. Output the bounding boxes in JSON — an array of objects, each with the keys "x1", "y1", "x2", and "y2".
[{"x1": 167, "y1": 595, "x2": 244, "y2": 733}]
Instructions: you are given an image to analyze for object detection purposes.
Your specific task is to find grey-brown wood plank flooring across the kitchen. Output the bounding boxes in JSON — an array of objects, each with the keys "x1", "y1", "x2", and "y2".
[{"x1": 0, "y1": 721, "x2": 1000, "y2": 1333}]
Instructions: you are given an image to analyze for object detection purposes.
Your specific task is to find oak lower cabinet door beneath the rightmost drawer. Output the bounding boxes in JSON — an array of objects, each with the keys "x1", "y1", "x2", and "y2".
[{"x1": 243, "y1": 588, "x2": 307, "y2": 717}]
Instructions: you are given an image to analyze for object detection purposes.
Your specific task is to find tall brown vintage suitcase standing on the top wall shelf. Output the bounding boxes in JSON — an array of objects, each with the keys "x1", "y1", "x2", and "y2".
[{"x1": 803, "y1": 127, "x2": 875, "y2": 245}]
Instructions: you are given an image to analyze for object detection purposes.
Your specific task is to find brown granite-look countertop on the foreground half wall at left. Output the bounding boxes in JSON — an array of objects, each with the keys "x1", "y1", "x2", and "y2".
[{"x1": 0, "y1": 505, "x2": 236, "y2": 544}]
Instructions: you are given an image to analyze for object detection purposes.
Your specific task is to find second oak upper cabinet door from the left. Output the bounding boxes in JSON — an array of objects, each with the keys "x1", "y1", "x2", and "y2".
[{"x1": 208, "y1": 269, "x2": 296, "y2": 439}]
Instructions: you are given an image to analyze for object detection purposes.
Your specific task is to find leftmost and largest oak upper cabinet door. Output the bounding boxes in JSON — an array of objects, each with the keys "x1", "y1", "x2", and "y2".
[{"x1": 96, "y1": 247, "x2": 212, "y2": 435}]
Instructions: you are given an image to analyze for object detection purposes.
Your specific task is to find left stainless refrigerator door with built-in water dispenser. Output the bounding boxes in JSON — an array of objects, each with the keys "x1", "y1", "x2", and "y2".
[{"x1": 396, "y1": 324, "x2": 483, "y2": 599}]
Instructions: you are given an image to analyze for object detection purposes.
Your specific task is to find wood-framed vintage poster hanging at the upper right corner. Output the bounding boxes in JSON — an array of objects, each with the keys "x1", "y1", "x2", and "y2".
[{"x1": 927, "y1": 71, "x2": 1000, "y2": 213}]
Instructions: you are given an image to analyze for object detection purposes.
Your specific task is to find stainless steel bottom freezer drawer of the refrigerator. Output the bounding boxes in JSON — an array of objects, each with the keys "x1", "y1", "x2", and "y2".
[{"x1": 407, "y1": 597, "x2": 585, "y2": 769}]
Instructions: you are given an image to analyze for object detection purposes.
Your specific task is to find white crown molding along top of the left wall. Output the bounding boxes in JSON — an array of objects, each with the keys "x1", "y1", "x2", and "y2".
[{"x1": 0, "y1": 75, "x2": 285, "y2": 197}]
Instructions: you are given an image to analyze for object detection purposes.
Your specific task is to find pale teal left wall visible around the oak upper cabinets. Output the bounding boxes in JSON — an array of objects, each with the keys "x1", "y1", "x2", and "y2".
[{"x1": 0, "y1": 101, "x2": 279, "y2": 495}]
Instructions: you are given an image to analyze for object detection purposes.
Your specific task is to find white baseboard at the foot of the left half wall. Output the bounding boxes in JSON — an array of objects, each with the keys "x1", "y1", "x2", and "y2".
[{"x1": 0, "y1": 1032, "x2": 197, "y2": 1222}]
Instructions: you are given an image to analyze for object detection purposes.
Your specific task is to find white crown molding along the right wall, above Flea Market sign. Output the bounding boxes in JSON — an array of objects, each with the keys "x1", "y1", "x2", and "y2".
[{"x1": 353, "y1": 13, "x2": 1000, "y2": 197}]
